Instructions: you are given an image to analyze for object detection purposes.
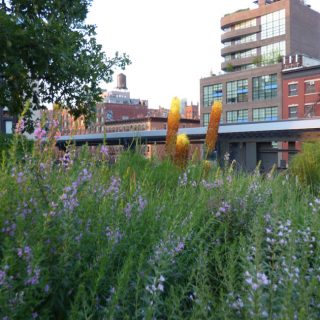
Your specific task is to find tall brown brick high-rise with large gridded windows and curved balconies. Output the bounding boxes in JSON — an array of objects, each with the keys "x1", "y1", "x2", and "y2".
[{"x1": 200, "y1": 0, "x2": 320, "y2": 125}]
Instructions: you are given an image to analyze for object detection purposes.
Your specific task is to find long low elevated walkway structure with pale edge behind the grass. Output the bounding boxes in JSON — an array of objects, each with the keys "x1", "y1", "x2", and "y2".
[{"x1": 57, "y1": 119, "x2": 320, "y2": 170}]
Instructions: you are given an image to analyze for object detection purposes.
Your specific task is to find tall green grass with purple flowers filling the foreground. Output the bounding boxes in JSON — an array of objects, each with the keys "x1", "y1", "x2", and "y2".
[{"x1": 0, "y1": 139, "x2": 320, "y2": 319}]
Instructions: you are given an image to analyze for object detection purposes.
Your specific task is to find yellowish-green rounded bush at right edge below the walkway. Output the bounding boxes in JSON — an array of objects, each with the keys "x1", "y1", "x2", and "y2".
[{"x1": 290, "y1": 141, "x2": 320, "y2": 192}]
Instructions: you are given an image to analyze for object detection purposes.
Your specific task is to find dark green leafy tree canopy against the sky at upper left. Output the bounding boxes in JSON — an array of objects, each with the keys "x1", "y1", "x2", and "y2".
[{"x1": 0, "y1": 0, "x2": 130, "y2": 127}]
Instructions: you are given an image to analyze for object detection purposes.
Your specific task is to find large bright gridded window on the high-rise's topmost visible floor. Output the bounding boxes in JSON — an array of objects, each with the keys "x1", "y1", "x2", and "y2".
[{"x1": 261, "y1": 9, "x2": 286, "y2": 40}]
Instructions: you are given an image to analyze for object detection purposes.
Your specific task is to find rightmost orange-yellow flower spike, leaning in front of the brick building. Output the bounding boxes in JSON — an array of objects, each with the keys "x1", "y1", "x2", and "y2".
[{"x1": 206, "y1": 101, "x2": 222, "y2": 156}]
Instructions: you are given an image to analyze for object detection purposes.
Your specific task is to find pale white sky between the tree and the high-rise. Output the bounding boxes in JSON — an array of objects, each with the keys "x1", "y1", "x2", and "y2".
[{"x1": 87, "y1": 0, "x2": 320, "y2": 108}]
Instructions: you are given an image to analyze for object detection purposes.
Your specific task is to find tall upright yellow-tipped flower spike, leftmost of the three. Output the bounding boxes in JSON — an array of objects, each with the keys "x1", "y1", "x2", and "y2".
[{"x1": 166, "y1": 97, "x2": 180, "y2": 158}]
